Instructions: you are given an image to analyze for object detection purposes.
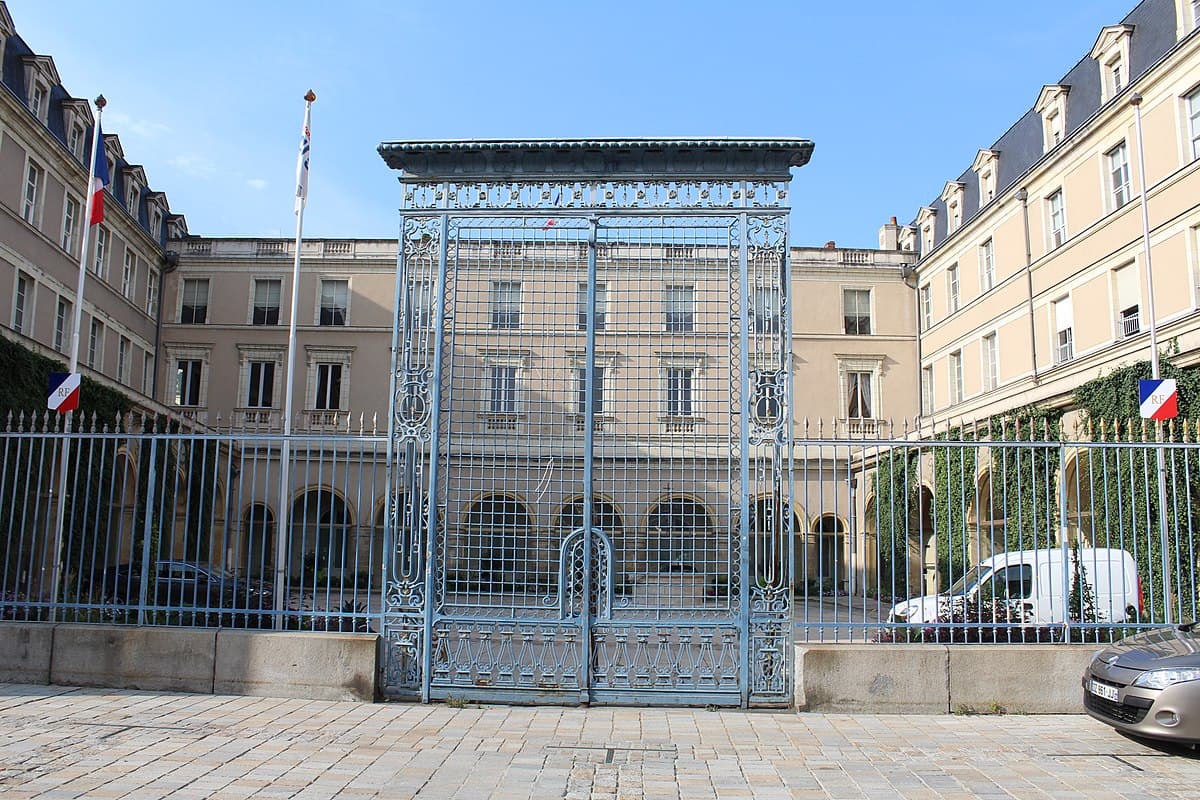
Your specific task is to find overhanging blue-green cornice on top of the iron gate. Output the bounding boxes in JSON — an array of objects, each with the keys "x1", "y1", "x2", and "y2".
[{"x1": 378, "y1": 138, "x2": 812, "y2": 184}]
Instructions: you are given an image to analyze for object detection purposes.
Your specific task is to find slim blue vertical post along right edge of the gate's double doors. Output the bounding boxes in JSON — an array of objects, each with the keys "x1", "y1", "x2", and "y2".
[{"x1": 730, "y1": 208, "x2": 754, "y2": 708}]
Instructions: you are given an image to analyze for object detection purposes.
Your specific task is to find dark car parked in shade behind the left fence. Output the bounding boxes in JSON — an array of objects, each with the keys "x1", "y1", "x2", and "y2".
[{"x1": 94, "y1": 561, "x2": 275, "y2": 627}]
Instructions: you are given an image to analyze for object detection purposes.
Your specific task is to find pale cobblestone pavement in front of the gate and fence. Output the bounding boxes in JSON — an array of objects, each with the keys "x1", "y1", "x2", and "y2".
[{"x1": 0, "y1": 684, "x2": 1200, "y2": 800}]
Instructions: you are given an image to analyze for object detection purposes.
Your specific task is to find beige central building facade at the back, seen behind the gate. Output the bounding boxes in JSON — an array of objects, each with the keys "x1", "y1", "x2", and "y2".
[{"x1": 160, "y1": 237, "x2": 917, "y2": 584}]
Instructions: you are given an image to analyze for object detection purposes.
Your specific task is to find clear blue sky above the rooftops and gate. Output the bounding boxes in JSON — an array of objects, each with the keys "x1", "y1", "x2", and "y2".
[{"x1": 16, "y1": 0, "x2": 1135, "y2": 247}]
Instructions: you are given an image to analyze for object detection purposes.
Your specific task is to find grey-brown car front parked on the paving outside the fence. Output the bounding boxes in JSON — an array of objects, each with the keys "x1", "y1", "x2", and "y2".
[{"x1": 1084, "y1": 622, "x2": 1200, "y2": 744}]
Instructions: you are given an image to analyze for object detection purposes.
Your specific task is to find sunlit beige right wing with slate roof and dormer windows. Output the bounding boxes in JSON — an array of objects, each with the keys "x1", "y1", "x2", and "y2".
[{"x1": 901, "y1": 0, "x2": 1200, "y2": 429}]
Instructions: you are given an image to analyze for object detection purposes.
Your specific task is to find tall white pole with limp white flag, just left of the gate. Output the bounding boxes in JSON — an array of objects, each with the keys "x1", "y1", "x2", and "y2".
[{"x1": 275, "y1": 89, "x2": 317, "y2": 631}]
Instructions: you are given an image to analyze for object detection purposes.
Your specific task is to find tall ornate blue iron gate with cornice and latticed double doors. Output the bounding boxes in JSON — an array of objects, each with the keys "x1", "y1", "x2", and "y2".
[{"x1": 380, "y1": 140, "x2": 811, "y2": 705}]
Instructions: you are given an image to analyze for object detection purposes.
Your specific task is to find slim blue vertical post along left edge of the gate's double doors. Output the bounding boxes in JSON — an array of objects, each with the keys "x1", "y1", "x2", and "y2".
[{"x1": 420, "y1": 213, "x2": 450, "y2": 703}]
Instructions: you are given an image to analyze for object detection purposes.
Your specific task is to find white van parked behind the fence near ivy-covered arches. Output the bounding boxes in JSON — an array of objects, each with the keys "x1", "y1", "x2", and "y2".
[{"x1": 888, "y1": 548, "x2": 1142, "y2": 625}]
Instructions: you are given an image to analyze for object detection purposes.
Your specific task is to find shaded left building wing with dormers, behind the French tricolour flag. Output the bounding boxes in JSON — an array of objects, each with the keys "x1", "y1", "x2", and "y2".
[{"x1": 0, "y1": 2, "x2": 187, "y2": 410}]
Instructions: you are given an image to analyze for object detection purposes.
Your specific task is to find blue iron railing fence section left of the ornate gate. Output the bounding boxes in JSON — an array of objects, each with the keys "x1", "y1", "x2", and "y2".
[{"x1": 0, "y1": 415, "x2": 386, "y2": 631}]
